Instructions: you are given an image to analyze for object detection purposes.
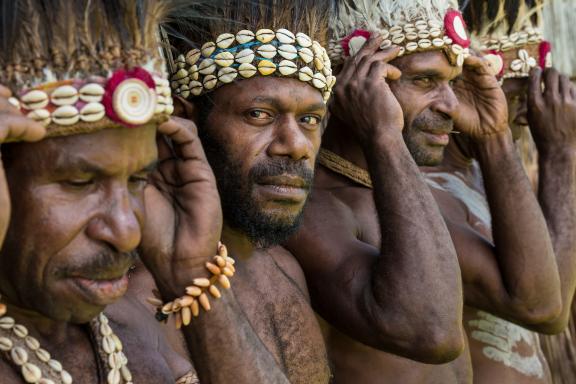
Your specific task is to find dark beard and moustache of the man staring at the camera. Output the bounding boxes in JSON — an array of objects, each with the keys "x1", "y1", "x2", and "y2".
[{"x1": 199, "y1": 127, "x2": 314, "y2": 248}]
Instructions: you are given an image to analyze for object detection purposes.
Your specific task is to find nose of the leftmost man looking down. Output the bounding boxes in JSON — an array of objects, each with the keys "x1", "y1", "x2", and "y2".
[{"x1": 87, "y1": 188, "x2": 142, "y2": 253}]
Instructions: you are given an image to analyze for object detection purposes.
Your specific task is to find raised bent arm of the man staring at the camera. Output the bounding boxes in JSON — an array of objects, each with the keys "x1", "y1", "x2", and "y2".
[{"x1": 288, "y1": 39, "x2": 463, "y2": 363}]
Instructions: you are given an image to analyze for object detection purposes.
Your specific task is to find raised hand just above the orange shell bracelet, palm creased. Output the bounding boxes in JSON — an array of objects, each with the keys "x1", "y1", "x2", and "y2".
[{"x1": 140, "y1": 117, "x2": 222, "y2": 300}]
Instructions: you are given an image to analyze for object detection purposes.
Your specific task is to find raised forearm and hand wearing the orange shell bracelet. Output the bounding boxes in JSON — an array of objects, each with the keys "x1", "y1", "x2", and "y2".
[{"x1": 140, "y1": 118, "x2": 289, "y2": 384}]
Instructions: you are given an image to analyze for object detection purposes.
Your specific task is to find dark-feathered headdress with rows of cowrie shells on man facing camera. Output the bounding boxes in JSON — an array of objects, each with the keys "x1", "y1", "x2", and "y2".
[{"x1": 166, "y1": 0, "x2": 336, "y2": 103}]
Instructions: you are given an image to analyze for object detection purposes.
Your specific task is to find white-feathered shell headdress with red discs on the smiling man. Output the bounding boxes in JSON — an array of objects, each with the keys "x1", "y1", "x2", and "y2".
[{"x1": 329, "y1": 0, "x2": 470, "y2": 66}]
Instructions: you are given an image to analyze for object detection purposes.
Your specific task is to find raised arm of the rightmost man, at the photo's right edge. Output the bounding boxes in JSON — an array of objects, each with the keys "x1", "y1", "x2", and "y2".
[{"x1": 528, "y1": 69, "x2": 576, "y2": 333}]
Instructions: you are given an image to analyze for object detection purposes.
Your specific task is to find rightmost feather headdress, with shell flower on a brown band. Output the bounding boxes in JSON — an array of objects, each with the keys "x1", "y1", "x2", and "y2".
[{"x1": 462, "y1": 0, "x2": 551, "y2": 79}]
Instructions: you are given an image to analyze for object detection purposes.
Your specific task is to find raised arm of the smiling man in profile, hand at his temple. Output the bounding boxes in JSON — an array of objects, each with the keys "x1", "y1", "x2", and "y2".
[{"x1": 450, "y1": 57, "x2": 561, "y2": 331}]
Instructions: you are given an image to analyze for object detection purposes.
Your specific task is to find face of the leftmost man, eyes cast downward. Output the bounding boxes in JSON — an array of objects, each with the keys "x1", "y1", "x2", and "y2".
[{"x1": 0, "y1": 125, "x2": 157, "y2": 323}]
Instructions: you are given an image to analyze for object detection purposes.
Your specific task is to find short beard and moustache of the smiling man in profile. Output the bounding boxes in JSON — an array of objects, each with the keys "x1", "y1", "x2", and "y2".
[{"x1": 402, "y1": 110, "x2": 453, "y2": 166}]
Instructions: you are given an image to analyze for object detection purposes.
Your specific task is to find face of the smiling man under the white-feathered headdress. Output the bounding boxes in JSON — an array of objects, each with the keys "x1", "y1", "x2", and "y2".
[{"x1": 390, "y1": 51, "x2": 461, "y2": 166}]
